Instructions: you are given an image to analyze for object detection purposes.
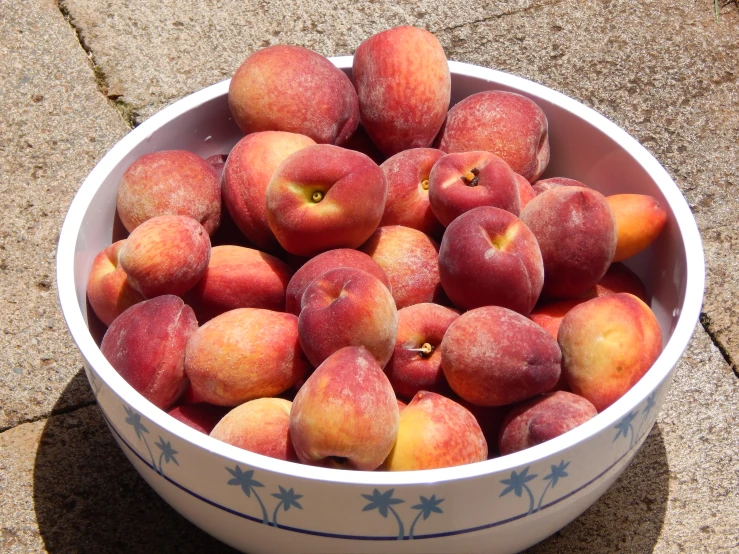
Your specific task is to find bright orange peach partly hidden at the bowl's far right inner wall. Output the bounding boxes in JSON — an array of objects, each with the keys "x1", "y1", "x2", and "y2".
[{"x1": 606, "y1": 194, "x2": 667, "y2": 262}]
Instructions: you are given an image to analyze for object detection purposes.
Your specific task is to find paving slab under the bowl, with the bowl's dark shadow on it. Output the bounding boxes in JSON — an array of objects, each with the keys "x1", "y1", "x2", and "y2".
[{"x1": 0, "y1": 328, "x2": 739, "y2": 554}]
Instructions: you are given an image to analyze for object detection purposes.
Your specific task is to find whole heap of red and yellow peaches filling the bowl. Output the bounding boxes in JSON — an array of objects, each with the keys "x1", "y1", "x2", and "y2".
[{"x1": 87, "y1": 27, "x2": 666, "y2": 470}]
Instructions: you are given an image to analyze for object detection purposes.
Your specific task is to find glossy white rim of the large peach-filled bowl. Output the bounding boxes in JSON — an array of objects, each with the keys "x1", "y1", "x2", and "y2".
[{"x1": 56, "y1": 56, "x2": 705, "y2": 486}]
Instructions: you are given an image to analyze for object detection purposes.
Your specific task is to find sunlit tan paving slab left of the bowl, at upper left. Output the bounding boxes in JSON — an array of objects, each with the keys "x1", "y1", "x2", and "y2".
[{"x1": 0, "y1": 0, "x2": 128, "y2": 430}]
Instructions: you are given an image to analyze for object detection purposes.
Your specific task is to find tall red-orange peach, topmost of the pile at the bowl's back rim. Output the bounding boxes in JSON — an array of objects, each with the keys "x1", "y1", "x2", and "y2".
[{"x1": 352, "y1": 26, "x2": 451, "y2": 156}]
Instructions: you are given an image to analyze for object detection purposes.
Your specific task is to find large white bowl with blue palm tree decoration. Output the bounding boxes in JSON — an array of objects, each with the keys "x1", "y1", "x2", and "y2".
[{"x1": 57, "y1": 56, "x2": 705, "y2": 554}]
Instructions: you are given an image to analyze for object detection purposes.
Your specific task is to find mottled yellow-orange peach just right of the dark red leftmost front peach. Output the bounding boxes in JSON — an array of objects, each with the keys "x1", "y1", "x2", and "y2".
[{"x1": 185, "y1": 308, "x2": 310, "y2": 406}]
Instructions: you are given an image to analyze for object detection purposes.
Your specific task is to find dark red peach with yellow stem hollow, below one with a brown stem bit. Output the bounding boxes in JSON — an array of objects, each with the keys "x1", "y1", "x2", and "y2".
[{"x1": 439, "y1": 206, "x2": 544, "y2": 315}]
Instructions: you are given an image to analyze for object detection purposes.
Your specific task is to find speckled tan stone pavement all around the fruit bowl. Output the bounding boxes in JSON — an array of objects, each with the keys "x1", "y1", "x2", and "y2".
[{"x1": 0, "y1": 0, "x2": 739, "y2": 554}]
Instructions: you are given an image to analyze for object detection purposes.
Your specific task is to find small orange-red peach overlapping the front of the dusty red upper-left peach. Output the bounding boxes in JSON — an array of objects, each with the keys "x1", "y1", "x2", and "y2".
[{"x1": 118, "y1": 215, "x2": 210, "y2": 298}]
